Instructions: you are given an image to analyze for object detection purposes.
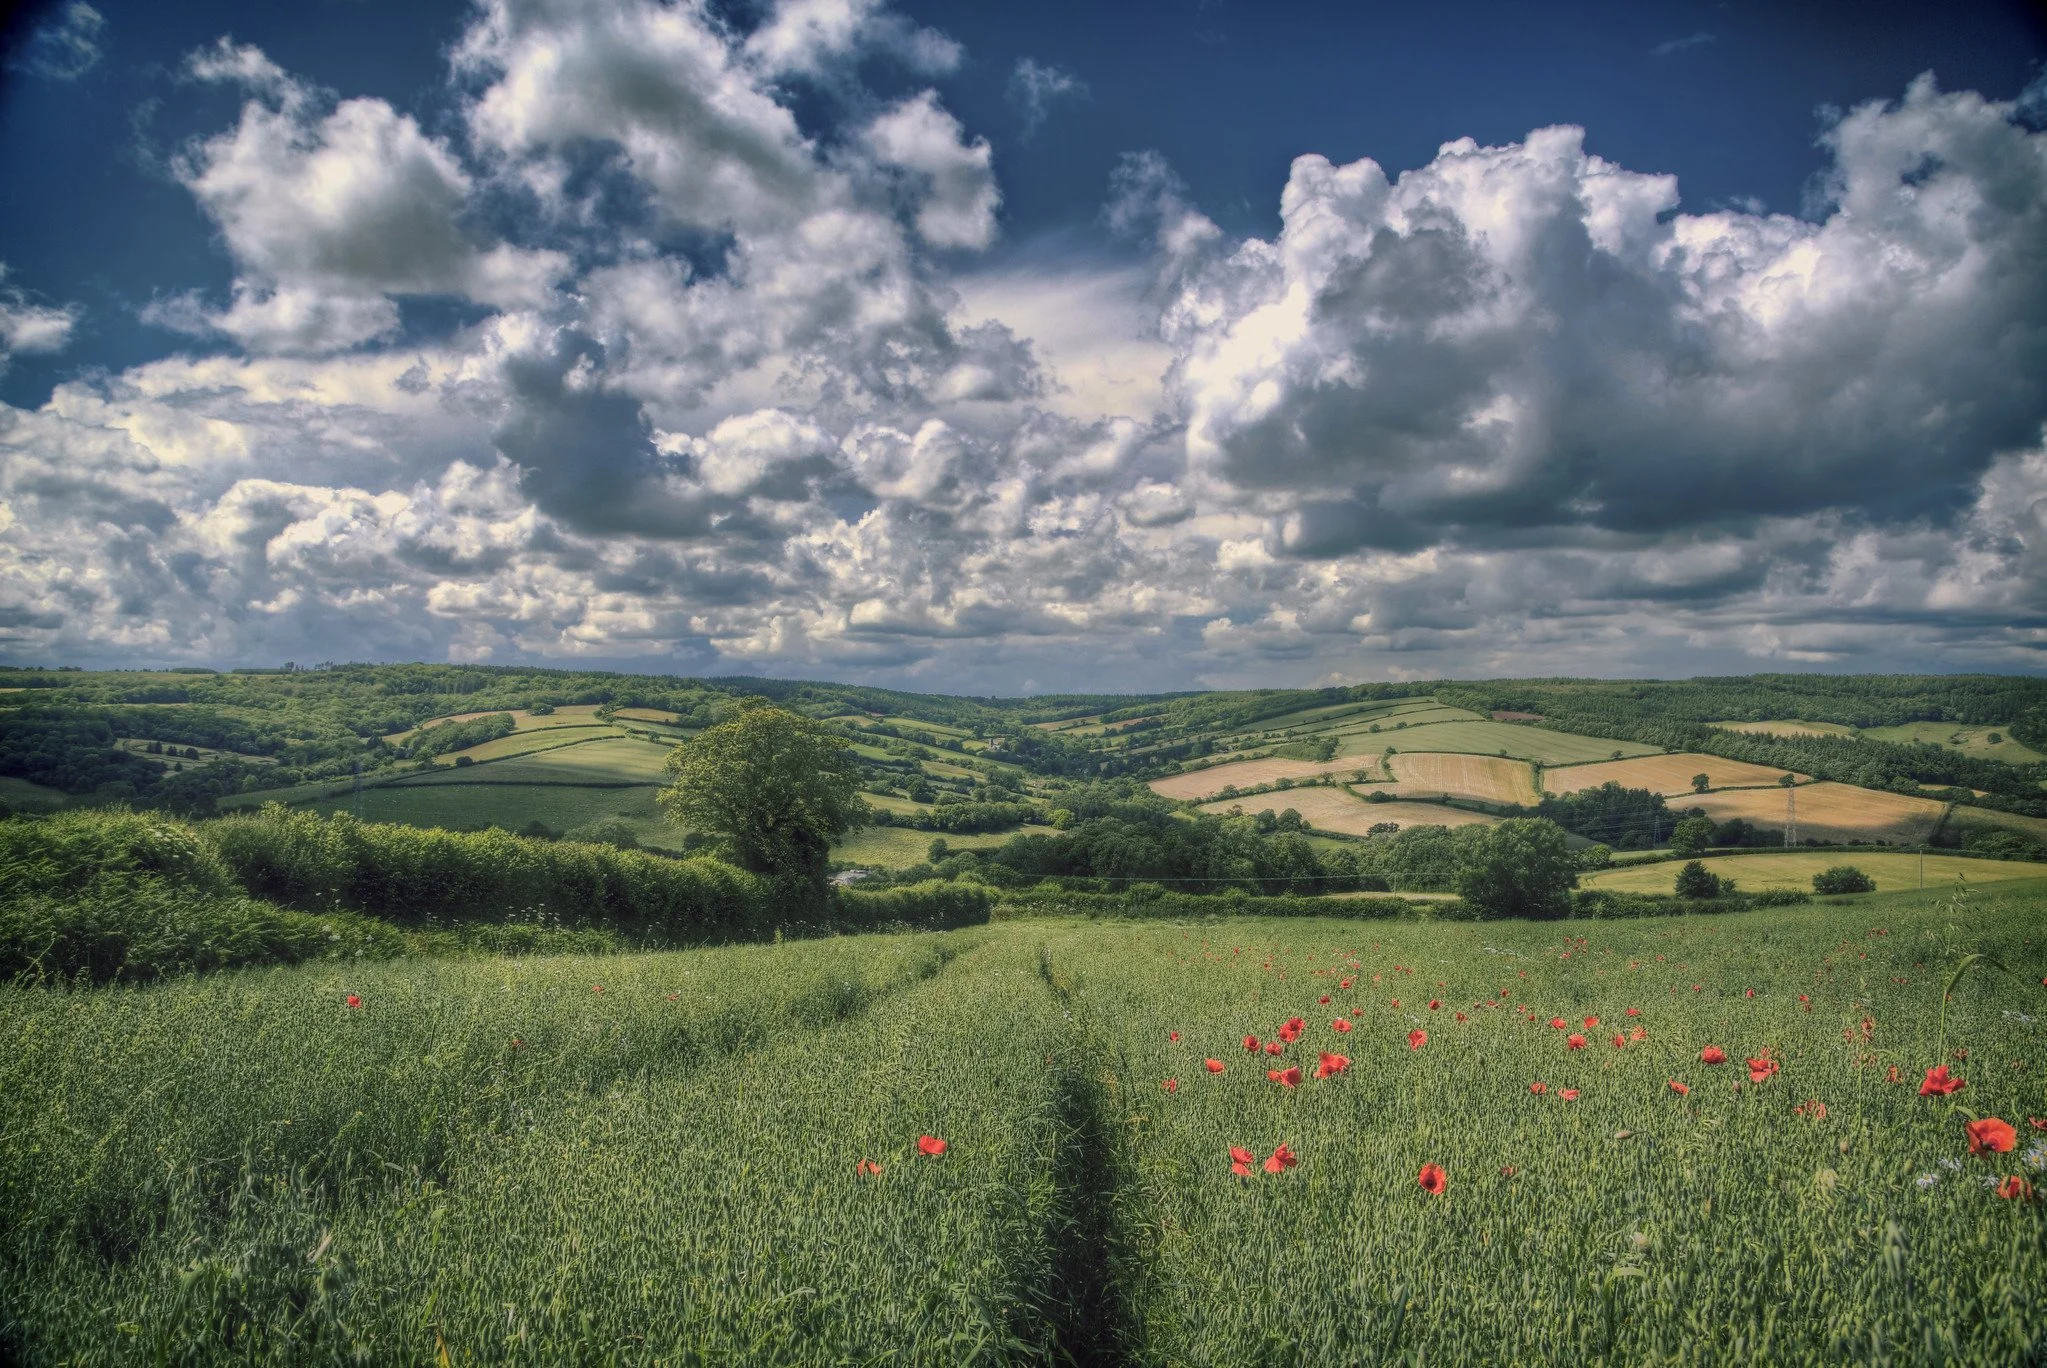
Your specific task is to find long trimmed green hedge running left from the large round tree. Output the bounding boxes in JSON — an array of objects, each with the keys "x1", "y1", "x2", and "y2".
[{"x1": 201, "y1": 805, "x2": 778, "y2": 942}]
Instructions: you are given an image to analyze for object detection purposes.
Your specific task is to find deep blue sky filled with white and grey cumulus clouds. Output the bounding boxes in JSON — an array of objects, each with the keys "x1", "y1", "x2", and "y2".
[{"x1": 0, "y1": 0, "x2": 2047, "y2": 694}]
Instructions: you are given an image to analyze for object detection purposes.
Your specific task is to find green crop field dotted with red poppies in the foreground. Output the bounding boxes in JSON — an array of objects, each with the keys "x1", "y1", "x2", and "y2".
[{"x1": 0, "y1": 891, "x2": 2047, "y2": 1364}]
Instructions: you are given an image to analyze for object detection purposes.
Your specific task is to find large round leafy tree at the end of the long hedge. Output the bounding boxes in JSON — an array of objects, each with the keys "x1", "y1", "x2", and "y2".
[{"x1": 659, "y1": 702, "x2": 868, "y2": 897}]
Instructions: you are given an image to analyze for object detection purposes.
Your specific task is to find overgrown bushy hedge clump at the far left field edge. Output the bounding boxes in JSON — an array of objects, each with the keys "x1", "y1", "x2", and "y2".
[{"x1": 0, "y1": 879, "x2": 405, "y2": 983}]
